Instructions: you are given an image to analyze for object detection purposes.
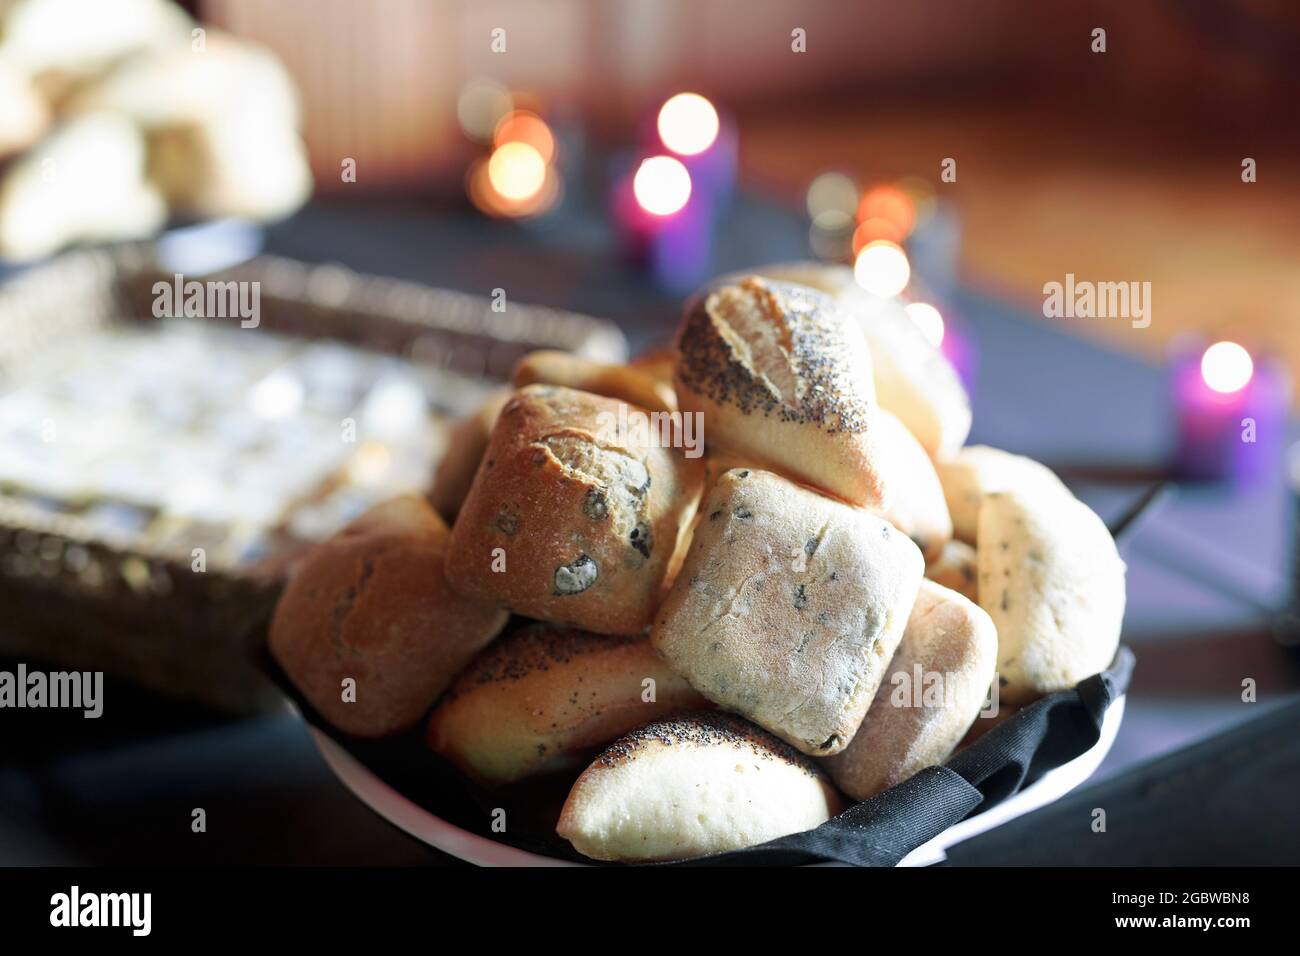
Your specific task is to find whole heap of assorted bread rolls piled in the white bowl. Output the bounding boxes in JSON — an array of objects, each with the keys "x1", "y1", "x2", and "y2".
[{"x1": 270, "y1": 264, "x2": 1125, "y2": 862}]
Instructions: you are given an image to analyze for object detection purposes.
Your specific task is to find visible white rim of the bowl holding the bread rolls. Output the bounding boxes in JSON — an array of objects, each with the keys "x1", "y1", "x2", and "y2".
[{"x1": 299, "y1": 697, "x2": 1125, "y2": 866}]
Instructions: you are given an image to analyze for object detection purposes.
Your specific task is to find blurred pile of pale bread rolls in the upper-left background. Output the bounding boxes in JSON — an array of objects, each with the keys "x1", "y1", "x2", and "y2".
[{"x1": 0, "y1": 0, "x2": 312, "y2": 261}]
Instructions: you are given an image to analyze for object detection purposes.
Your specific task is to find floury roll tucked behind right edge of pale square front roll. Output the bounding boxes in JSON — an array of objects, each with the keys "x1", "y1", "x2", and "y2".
[{"x1": 824, "y1": 581, "x2": 997, "y2": 800}]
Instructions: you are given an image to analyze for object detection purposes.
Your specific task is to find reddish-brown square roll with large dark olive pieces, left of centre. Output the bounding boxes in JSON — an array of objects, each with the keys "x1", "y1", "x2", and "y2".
[{"x1": 447, "y1": 385, "x2": 703, "y2": 633}]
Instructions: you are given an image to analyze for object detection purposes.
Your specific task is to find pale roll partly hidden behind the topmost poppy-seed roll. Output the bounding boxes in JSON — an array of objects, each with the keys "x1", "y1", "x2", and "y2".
[{"x1": 757, "y1": 263, "x2": 971, "y2": 458}]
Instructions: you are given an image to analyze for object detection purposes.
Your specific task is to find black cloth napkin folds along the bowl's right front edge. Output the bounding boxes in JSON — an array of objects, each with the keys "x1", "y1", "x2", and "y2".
[{"x1": 666, "y1": 646, "x2": 1134, "y2": 866}]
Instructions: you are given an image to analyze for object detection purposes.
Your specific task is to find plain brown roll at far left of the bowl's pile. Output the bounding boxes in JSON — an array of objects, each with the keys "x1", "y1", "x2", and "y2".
[{"x1": 270, "y1": 497, "x2": 507, "y2": 737}]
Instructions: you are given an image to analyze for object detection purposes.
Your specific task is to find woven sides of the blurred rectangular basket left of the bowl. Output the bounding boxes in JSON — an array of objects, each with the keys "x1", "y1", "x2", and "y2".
[{"x1": 0, "y1": 243, "x2": 627, "y2": 713}]
